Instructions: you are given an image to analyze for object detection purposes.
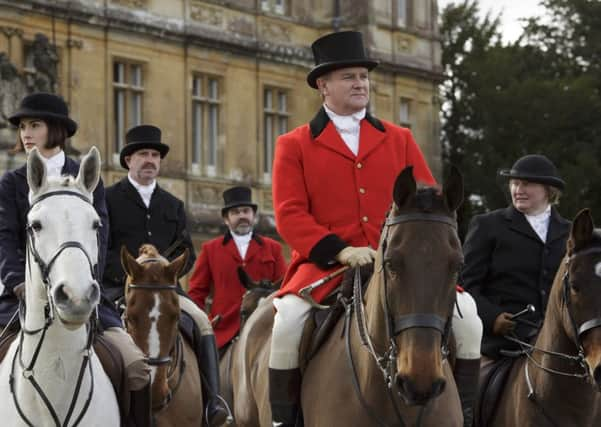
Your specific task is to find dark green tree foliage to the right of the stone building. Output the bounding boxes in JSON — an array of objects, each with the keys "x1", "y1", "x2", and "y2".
[{"x1": 441, "y1": 0, "x2": 601, "y2": 235}]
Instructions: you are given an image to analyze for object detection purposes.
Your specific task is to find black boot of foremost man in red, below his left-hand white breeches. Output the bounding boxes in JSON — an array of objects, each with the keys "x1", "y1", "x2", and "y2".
[{"x1": 269, "y1": 368, "x2": 301, "y2": 427}]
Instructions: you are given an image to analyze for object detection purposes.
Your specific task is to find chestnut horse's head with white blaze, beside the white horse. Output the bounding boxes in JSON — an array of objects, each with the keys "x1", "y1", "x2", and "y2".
[{"x1": 121, "y1": 244, "x2": 188, "y2": 401}]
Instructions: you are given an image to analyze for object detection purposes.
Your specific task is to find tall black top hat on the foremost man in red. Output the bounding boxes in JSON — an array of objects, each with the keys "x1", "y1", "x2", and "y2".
[{"x1": 307, "y1": 31, "x2": 378, "y2": 89}]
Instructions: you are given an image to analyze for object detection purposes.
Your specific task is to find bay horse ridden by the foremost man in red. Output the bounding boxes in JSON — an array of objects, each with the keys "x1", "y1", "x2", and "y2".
[{"x1": 232, "y1": 167, "x2": 463, "y2": 427}]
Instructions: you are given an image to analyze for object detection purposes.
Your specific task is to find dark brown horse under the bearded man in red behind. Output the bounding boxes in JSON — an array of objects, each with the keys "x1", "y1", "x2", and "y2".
[{"x1": 219, "y1": 267, "x2": 282, "y2": 422}]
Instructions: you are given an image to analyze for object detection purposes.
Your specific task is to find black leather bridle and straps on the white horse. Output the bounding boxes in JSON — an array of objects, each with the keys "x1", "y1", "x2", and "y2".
[{"x1": 9, "y1": 190, "x2": 99, "y2": 427}]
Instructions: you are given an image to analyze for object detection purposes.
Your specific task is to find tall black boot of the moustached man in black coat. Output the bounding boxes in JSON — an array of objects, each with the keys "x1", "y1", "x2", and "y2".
[{"x1": 196, "y1": 335, "x2": 232, "y2": 427}]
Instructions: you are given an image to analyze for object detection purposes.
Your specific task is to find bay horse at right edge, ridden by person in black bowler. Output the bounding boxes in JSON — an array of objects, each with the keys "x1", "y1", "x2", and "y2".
[{"x1": 489, "y1": 209, "x2": 601, "y2": 427}]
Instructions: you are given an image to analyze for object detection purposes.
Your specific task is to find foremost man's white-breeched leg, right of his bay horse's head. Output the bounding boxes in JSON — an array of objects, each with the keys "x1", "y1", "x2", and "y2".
[{"x1": 453, "y1": 291, "x2": 483, "y2": 359}]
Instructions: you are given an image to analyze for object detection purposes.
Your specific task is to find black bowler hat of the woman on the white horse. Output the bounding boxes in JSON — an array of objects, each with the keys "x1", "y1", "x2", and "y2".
[{"x1": 8, "y1": 92, "x2": 77, "y2": 137}]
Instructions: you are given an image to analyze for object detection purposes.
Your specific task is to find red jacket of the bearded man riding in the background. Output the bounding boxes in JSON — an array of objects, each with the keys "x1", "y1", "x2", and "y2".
[{"x1": 188, "y1": 232, "x2": 286, "y2": 347}]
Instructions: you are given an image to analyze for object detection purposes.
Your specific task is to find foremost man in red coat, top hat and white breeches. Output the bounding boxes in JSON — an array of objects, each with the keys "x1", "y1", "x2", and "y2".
[{"x1": 269, "y1": 31, "x2": 479, "y2": 427}]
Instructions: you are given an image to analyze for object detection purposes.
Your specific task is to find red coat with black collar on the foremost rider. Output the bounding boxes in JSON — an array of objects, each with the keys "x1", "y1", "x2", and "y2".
[{"x1": 273, "y1": 108, "x2": 435, "y2": 302}]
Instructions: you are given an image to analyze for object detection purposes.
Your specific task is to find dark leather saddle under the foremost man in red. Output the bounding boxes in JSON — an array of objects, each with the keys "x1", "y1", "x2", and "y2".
[{"x1": 299, "y1": 264, "x2": 373, "y2": 372}]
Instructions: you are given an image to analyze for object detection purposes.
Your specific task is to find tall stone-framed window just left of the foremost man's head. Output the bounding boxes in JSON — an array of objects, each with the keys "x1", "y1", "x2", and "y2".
[{"x1": 261, "y1": 85, "x2": 291, "y2": 184}]
